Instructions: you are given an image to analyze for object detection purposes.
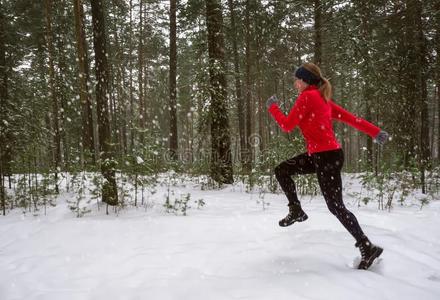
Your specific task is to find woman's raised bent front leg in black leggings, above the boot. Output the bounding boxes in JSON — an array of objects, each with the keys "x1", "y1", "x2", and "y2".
[{"x1": 275, "y1": 153, "x2": 315, "y2": 207}]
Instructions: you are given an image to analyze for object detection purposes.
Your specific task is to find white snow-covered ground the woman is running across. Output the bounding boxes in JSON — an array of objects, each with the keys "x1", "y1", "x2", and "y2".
[{"x1": 0, "y1": 175, "x2": 440, "y2": 300}]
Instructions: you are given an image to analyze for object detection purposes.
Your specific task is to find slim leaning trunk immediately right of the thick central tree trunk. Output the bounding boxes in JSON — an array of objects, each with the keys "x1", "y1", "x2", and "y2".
[{"x1": 228, "y1": 0, "x2": 247, "y2": 166}]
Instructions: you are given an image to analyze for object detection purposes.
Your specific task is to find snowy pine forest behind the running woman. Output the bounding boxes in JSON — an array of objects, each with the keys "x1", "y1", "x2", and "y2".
[{"x1": 0, "y1": 0, "x2": 440, "y2": 214}]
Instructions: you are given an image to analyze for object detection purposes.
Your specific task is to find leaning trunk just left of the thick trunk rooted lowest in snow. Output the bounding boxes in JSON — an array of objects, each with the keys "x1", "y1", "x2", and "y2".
[{"x1": 73, "y1": 0, "x2": 95, "y2": 164}]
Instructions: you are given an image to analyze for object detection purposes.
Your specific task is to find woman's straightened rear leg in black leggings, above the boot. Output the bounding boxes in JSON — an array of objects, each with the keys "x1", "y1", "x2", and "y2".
[{"x1": 313, "y1": 149, "x2": 364, "y2": 242}]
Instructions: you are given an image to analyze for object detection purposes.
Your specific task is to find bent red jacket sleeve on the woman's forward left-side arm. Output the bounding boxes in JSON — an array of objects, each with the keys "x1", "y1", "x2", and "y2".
[{"x1": 269, "y1": 95, "x2": 308, "y2": 132}]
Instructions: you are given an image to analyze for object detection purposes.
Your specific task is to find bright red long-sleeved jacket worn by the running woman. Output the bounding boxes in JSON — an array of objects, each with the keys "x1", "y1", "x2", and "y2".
[{"x1": 269, "y1": 85, "x2": 380, "y2": 154}]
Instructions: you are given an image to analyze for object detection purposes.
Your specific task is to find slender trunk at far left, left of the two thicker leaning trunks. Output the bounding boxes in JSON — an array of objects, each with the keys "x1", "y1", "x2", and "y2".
[{"x1": 45, "y1": 0, "x2": 61, "y2": 193}]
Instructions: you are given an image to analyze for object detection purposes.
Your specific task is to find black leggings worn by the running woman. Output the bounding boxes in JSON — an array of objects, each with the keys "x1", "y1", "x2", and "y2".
[{"x1": 275, "y1": 149, "x2": 364, "y2": 241}]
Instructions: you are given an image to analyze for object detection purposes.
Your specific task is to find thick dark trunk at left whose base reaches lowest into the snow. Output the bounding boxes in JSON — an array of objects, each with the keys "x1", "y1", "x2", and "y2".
[{"x1": 91, "y1": 0, "x2": 118, "y2": 205}]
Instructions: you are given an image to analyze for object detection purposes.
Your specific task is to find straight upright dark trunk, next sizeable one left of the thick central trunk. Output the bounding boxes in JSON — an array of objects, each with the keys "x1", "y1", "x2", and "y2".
[{"x1": 169, "y1": 0, "x2": 178, "y2": 160}]
